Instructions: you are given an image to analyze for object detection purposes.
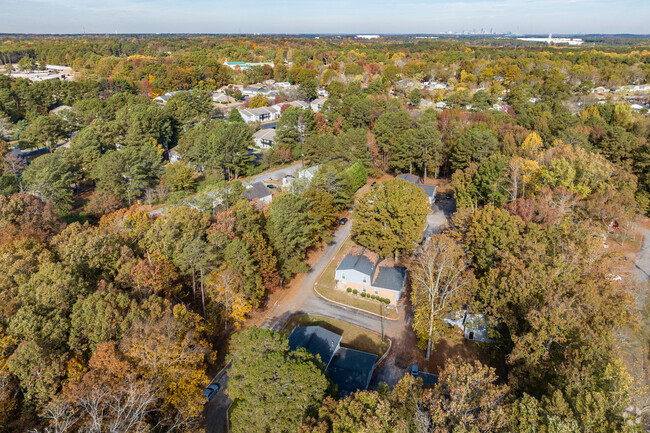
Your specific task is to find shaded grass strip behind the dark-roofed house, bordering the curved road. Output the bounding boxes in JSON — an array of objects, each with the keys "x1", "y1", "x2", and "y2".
[{"x1": 281, "y1": 314, "x2": 388, "y2": 357}]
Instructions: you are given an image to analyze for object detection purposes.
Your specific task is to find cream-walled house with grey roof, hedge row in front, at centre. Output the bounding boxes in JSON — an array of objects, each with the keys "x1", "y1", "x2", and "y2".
[{"x1": 334, "y1": 246, "x2": 406, "y2": 305}]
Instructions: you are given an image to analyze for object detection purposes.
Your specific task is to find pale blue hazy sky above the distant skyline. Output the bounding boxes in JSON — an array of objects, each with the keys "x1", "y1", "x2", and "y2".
[{"x1": 0, "y1": 0, "x2": 650, "y2": 34}]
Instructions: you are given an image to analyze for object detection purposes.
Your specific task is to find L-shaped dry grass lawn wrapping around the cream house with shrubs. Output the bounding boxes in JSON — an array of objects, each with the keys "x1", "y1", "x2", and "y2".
[{"x1": 315, "y1": 238, "x2": 400, "y2": 319}]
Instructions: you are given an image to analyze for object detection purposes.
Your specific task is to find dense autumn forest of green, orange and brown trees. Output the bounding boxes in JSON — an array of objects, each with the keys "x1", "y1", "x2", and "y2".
[{"x1": 0, "y1": 35, "x2": 650, "y2": 433}]
